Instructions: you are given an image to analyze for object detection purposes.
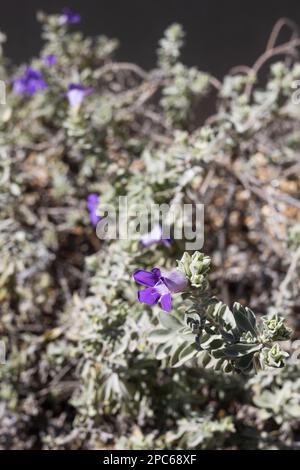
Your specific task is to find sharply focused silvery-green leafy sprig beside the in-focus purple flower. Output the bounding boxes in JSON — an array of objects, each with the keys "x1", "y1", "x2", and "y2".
[{"x1": 149, "y1": 252, "x2": 290, "y2": 373}]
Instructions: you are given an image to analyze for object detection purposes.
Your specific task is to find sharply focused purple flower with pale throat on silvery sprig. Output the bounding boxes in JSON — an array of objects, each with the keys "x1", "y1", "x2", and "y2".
[{"x1": 133, "y1": 268, "x2": 187, "y2": 312}]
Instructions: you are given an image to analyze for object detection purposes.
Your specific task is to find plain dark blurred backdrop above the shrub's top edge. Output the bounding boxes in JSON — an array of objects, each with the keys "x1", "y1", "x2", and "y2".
[{"x1": 0, "y1": 0, "x2": 300, "y2": 77}]
